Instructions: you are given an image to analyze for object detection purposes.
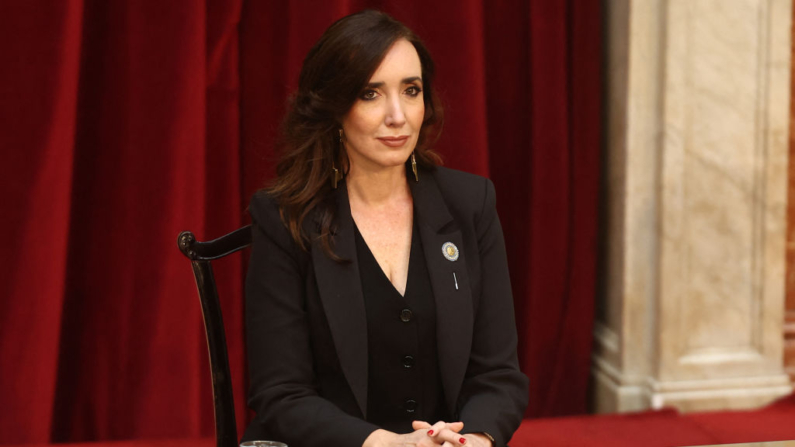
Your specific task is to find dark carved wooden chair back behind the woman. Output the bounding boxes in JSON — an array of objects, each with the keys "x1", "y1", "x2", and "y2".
[{"x1": 177, "y1": 225, "x2": 251, "y2": 447}]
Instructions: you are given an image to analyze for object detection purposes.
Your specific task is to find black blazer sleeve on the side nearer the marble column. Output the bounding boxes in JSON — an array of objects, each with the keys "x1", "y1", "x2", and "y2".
[{"x1": 459, "y1": 179, "x2": 528, "y2": 447}]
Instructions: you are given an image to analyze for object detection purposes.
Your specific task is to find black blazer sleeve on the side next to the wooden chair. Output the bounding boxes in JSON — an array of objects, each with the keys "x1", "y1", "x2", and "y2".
[{"x1": 246, "y1": 194, "x2": 378, "y2": 447}]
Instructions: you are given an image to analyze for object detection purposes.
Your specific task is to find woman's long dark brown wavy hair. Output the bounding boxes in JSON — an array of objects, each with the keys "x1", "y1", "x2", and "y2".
[{"x1": 266, "y1": 10, "x2": 443, "y2": 261}]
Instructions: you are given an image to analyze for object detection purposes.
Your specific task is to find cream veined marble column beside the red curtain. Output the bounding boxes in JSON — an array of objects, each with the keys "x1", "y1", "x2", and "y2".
[{"x1": 593, "y1": 0, "x2": 792, "y2": 412}]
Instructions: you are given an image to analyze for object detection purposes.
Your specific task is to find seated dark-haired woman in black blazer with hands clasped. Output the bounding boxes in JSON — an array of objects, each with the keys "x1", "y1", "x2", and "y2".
[{"x1": 244, "y1": 11, "x2": 527, "y2": 447}]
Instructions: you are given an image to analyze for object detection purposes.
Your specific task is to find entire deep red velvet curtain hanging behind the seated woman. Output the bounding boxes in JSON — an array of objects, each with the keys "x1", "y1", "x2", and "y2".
[{"x1": 0, "y1": 0, "x2": 600, "y2": 444}]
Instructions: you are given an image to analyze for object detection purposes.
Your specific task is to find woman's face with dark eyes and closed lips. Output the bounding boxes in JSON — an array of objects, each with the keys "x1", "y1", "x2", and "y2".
[{"x1": 342, "y1": 39, "x2": 425, "y2": 172}]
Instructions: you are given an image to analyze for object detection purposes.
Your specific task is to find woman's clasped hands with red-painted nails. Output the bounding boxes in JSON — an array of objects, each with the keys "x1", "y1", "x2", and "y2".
[{"x1": 363, "y1": 421, "x2": 494, "y2": 447}]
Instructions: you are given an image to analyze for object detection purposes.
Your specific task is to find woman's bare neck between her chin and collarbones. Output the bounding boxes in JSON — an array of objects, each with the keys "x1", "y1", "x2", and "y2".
[{"x1": 345, "y1": 166, "x2": 411, "y2": 206}]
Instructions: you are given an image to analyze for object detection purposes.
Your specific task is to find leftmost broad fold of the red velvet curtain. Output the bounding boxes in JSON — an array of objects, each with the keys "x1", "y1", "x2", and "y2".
[{"x1": 0, "y1": 1, "x2": 82, "y2": 442}]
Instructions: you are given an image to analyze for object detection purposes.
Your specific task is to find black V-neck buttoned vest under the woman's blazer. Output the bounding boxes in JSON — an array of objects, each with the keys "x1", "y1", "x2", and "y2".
[{"x1": 354, "y1": 222, "x2": 449, "y2": 433}]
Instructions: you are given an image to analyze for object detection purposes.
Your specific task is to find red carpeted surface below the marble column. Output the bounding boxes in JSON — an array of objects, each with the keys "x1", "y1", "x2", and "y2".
[{"x1": 511, "y1": 395, "x2": 795, "y2": 447}]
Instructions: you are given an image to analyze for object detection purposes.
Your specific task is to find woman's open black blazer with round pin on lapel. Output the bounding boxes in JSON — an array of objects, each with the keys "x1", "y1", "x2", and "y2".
[{"x1": 244, "y1": 168, "x2": 528, "y2": 447}]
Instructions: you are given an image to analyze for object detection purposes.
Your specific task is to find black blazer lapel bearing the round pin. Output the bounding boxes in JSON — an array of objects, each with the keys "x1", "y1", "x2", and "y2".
[{"x1": 409, "y1": 171, "x2": 474, "y2": 415}]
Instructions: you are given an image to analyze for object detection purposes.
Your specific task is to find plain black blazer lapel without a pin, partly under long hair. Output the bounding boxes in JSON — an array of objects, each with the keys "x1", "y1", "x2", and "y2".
[{"x1": 309, "y1": 183, "x2": 367, "y2": 418}]
